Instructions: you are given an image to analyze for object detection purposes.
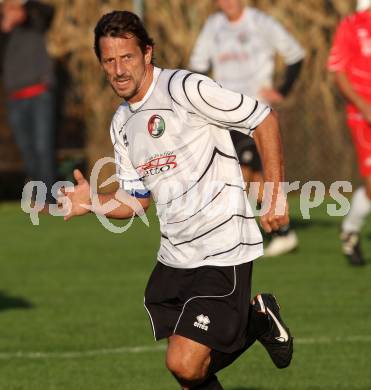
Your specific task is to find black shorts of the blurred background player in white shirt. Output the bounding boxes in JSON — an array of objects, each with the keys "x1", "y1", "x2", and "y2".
[{"x1": 231, "y1": 131, "x2": 263, "y2": 172}]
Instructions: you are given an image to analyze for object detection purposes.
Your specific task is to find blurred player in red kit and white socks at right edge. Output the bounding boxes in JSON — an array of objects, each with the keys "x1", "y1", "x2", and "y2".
[{"x1": 328, "y1": 0, "x2": 371, "y2": 265}]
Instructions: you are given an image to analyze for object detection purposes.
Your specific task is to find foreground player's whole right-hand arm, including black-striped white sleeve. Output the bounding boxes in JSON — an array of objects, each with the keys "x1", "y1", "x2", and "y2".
[{"x1": 169, "y1": 71, "x2": 288, "y2": 232}]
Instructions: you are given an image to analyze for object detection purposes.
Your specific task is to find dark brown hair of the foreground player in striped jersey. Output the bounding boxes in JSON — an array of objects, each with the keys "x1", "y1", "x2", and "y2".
[{"x1": 94, "y1": 11, "x2": 155, "y2": 62}]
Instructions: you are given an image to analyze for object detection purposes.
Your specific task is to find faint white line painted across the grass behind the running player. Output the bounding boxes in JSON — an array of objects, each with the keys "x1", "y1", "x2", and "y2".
[{"x1": 0, "y1": 336, "x2": 371, "y2": 360}]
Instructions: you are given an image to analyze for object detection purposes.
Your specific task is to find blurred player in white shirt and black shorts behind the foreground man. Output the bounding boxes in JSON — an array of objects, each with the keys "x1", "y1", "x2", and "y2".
[{"x1": 190, "y1": 0, "x2": 304, "y2": 256}]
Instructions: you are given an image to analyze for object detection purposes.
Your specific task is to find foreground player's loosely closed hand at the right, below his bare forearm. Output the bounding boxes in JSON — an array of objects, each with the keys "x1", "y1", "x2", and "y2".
[{"x1": 260, "y1": 190, "x2": 290, "y2": 233}]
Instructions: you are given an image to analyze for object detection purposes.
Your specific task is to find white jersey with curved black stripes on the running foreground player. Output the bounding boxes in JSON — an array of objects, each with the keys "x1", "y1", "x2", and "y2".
[{"x1": 111, "y1": 68, "x2": 270, "y2": 268}]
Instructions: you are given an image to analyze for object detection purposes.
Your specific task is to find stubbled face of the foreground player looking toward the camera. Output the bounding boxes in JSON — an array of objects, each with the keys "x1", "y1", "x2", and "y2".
[{"x1": 99, "y1": 37, "x2": 152, "y2": 103}]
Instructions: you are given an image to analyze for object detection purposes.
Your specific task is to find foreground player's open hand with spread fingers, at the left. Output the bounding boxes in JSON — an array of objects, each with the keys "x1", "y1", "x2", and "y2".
[{"x1": 57, "y1": 169, "x2": 91, "y2": 221}]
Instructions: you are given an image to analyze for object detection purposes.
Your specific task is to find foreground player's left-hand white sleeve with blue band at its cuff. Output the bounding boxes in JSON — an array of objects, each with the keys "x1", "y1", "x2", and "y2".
[{"x1": 110, "y1": 114, "x2": 150, "y2": 198}]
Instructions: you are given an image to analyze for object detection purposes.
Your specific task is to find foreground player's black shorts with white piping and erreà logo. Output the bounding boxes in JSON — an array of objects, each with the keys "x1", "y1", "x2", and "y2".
[{"x1": 145, "y1": 262, "x2": 252, "y2": 353}]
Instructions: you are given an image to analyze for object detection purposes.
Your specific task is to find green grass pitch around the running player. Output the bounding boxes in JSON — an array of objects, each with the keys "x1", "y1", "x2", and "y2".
[{"x1": 0, "y1": 199, "x2": 371, "y2": 390}]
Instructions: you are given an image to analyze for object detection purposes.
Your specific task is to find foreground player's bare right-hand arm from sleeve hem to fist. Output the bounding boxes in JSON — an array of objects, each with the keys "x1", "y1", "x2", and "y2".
[{"x1": 253, "y1": 112, "x2": 289, "y2": 233}]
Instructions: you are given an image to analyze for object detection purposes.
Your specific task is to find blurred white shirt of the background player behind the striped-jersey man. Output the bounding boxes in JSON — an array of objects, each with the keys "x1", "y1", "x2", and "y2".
[{"x1": 190, "y1": 7, "x2": 305, "y2": 98}]
